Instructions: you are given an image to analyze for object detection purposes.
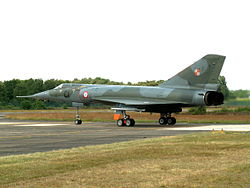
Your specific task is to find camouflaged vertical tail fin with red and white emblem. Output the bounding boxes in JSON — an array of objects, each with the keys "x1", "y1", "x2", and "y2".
[{"x1": 159, "y1": 55, "x2": 226, "y2": 90}]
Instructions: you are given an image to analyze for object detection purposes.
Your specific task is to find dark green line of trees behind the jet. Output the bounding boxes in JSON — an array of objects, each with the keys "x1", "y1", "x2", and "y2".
[{"x1": 0, "y1": 77, "x2": 249, "y2": 109}]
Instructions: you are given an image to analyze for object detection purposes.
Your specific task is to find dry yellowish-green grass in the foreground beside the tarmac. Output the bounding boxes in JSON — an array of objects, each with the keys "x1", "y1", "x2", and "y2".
[{"x1": 0, "y1": 132, "x2": 250, "y2": 188}]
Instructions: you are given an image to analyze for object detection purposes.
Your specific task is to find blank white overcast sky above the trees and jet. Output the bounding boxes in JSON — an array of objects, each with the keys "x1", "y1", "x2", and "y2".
[{"x1": 0, "y1": 0, "x2": 250, "y2": 89}]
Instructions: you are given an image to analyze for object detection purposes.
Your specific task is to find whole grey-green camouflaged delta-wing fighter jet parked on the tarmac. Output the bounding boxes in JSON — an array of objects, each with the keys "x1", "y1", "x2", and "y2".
[{"x1": 18, "y1": 54, "x2": 226, "y2": 126}]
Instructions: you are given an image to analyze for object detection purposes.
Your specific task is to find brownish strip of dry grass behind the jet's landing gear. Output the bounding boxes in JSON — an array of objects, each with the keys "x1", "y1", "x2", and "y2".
[{"x1": 7, "y1": 110, "x2": 250, "y2": 123}]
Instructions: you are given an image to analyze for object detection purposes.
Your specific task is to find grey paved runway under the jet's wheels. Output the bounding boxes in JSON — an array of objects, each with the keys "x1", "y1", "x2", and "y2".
[{"x1": 0, "y1": 119, "x2": 250, "y2": 156}]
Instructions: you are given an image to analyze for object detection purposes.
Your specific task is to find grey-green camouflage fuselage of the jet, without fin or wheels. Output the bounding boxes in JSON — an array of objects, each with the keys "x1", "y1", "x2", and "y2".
[{"x1": 34, "y1": 83, "x2": 221, "y2": 113}]
